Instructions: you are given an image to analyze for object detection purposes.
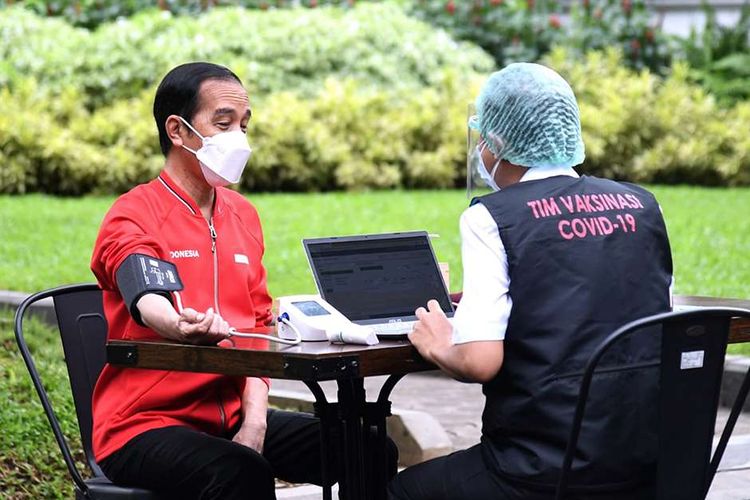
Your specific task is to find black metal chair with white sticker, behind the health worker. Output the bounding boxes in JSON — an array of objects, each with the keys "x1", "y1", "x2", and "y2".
[{"x1": 555, "y1": 308, "x2": 750, "y2": 500}]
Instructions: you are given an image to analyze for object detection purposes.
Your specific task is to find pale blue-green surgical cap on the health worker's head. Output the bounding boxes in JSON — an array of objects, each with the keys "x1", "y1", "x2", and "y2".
[{"x1": 473, "y1": 63, "x2": 586, "y2": 168}]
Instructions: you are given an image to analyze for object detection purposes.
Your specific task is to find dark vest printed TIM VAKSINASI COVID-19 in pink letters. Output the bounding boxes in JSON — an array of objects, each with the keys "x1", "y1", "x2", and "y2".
[{"x1": 475, "y1": 176, "x2": 672, "y2": 490}]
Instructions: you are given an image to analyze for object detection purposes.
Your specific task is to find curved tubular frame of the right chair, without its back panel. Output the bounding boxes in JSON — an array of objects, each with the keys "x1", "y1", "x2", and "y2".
[{"x1": 555, "y1": 307, "x2": 750, "y2": 500}]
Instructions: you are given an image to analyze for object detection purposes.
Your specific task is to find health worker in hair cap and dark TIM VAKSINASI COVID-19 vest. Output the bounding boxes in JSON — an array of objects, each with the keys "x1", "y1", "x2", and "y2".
[{"x1": 389, "y1": 63, "x2": 672, "y2": 500}]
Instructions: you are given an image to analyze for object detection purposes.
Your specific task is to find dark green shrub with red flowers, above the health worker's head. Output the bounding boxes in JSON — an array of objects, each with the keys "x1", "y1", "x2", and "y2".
[{"x1": 408, "y1": 0, "x2": 672, "y2": 72}]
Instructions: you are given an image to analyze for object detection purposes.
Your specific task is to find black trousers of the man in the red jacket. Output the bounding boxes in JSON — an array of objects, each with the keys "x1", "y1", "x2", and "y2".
[{"x1": 99, "y1": 410, "x2": 398, "y2": 500}]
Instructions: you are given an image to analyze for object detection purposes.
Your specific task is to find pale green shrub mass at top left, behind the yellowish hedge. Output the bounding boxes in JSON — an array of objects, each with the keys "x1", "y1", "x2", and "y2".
[{"x1": 0, "y1": 4, "x2": 493, "y2": 109}]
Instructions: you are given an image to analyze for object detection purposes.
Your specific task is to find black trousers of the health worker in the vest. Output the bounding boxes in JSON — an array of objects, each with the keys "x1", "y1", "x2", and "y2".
[{"x1": 388, "y1": 444, "x2": 654, "y2": 500}]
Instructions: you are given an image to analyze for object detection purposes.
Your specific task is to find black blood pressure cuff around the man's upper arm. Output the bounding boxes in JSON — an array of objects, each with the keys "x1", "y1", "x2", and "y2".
[{"x1": 115, "y1": 253, "x2": 183, "y2": 326}]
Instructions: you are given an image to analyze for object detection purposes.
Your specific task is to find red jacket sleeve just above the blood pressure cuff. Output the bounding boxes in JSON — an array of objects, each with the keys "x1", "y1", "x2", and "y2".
[{"x1": 91, "y1": 198, "x2": 163, "y2": 290}]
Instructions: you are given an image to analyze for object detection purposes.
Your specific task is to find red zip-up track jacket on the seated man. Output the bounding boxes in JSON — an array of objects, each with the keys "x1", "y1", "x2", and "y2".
[{"x1": 91, "y1": 172, "x2": 271, "y2": 460}]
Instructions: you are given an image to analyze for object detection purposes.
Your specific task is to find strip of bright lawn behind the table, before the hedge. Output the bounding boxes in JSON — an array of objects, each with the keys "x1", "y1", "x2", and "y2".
[{"x1": 0, "y1": 187, "x2": 750, "y2": 298}]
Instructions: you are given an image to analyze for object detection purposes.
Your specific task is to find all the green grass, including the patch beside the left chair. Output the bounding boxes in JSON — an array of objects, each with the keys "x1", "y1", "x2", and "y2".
[{"x1": 0, "y1": 187, "x2": 750, "y2": 499}]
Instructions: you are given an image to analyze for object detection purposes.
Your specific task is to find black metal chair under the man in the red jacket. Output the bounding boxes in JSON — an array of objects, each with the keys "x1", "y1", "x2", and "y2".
[{"x1": 15, "y1": 284, "x2": 157, "y2": 500}]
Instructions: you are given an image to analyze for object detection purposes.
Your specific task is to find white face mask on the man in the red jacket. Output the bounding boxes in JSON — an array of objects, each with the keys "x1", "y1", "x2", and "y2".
[{"x1": 179, "y1": 116, "x2": 253, "y2": 187}]
